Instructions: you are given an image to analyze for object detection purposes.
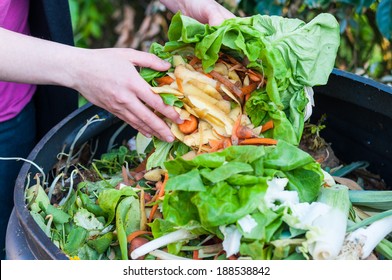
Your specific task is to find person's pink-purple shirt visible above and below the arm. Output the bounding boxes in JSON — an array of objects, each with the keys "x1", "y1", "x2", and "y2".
[{"x1": 0, "y1": 0, "x2": 36, "y2": 122}]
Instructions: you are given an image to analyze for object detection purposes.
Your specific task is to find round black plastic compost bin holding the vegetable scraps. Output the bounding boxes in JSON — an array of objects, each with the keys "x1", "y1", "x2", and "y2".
[{"x1": 6, "y1": 69, "x2": 392, "y2": 260}]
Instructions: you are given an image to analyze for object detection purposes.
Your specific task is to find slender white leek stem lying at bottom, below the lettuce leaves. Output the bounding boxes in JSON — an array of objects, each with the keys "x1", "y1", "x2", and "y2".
[{"x1": 131, "y1": 229, "x2": 197, "y2": 259}]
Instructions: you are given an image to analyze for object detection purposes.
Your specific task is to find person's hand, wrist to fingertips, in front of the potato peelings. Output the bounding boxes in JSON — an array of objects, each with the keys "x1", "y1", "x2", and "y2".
[{"x1": 72, "y1": 48, "x2": 182, "y2": 142}]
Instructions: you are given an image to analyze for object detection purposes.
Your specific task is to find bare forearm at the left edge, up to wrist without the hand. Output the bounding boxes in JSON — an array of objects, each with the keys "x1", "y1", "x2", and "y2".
[{"x1": 0, "y1": 28, "x2": 81, "y2": 87}]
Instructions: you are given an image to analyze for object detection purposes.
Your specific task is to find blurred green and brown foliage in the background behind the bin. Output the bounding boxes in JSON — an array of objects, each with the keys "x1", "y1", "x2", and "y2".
[{"x1": 69, "y1": 0, "x2": 392, "y2": 83}]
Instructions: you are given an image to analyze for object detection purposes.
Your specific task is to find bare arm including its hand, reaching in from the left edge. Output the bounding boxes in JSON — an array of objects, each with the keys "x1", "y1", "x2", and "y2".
[{"x1": 0, "y1": 28, "x2": 181, "y2": 141}]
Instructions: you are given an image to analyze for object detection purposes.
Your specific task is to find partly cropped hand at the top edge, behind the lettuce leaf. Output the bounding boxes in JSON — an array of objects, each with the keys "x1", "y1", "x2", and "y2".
[{"x1": 161, "y1": 0, "x2": 235, "y2": 25}]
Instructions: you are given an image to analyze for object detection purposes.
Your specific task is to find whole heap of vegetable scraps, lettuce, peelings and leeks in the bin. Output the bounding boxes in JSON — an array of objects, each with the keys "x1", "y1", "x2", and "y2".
[{"x1": 26, "y1": 13, "x2": 392, "y2": 260}]
